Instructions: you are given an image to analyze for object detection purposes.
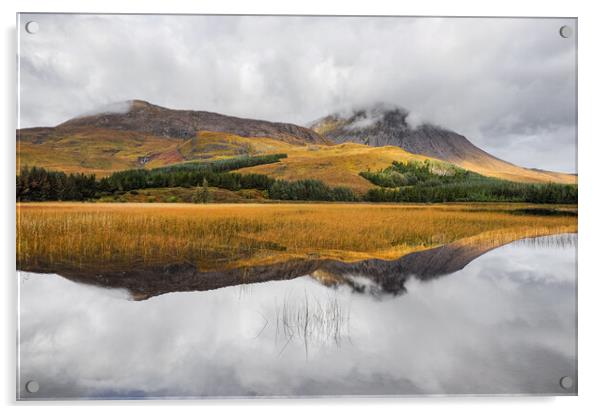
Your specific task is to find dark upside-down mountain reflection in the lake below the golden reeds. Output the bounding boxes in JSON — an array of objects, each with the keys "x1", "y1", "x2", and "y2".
[{"x1": 39, "y1": 231, "x2": 575, "y2": 300}]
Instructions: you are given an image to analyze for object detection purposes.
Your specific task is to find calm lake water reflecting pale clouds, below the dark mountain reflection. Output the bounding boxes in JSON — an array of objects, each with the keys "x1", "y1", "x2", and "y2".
[{"x1": 18, "y1": 235, "x2": 577, "y2": 399}]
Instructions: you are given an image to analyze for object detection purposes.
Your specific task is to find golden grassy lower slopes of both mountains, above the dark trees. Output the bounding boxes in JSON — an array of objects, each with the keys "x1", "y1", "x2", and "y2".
[{"x1": 17, "y1": 128, "x2": 577, "y2": 184}]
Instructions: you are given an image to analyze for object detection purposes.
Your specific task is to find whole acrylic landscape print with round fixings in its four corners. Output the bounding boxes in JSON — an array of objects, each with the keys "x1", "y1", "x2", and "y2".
[{"x1": 16, "y1": 13, "x2": 578, "y2": 400}]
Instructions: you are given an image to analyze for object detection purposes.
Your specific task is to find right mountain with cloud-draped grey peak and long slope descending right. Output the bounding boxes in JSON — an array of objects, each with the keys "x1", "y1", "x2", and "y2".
[{"x1": 310, "y1": 104, "x2": 576, "y2": 183}]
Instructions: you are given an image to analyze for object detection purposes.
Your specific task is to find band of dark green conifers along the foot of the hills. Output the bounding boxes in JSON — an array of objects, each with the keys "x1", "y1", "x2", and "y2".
[{"x1": 16, "y1": 154, "x2": 578, "y2": 204}]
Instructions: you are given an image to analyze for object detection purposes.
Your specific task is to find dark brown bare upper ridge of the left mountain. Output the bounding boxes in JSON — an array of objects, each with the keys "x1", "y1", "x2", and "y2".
[{"x1": 58, "y1": 100, "x2": 329, "y2": 144}]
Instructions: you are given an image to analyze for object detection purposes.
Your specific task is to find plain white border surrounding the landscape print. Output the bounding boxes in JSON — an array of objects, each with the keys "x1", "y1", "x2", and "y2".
[{"x1": 0, "y1": 0, "x2": 602, "y2": 414}]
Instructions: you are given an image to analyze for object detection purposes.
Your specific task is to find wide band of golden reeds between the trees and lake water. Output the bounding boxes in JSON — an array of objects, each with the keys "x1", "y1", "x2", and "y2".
[{"x1": 17, "y1": 203, "x2": 577, "y2": 271}]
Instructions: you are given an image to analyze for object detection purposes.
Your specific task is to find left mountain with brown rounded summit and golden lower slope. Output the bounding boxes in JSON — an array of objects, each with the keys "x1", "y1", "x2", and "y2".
[{"x1": 17, "y1": 100, "x2": 331, "y2": 176}]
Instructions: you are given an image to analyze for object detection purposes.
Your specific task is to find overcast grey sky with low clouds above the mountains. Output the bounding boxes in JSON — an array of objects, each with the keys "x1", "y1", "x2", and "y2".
[{"x1": 19, "y1": 15, "x2": 576, "y2": 172}]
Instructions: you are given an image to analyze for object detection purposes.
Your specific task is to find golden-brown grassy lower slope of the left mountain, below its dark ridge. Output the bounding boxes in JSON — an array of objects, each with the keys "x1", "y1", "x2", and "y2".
[{"x1": 17, "y1": 127, "x2": 297, "y2": 176}]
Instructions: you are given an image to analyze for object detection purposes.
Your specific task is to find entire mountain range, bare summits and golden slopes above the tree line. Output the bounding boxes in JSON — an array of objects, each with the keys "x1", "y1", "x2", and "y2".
[{"x1": 17, "y1": 100, "x2": 577, "y2": 187}]
